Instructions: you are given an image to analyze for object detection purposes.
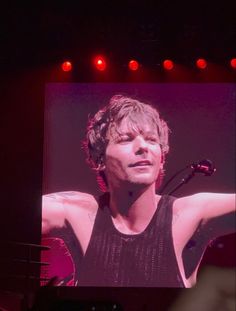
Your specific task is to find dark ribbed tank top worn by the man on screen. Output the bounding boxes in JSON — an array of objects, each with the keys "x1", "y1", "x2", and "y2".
[{"x1": 70, "y1": 196, "x2": 184, "y2": 287}]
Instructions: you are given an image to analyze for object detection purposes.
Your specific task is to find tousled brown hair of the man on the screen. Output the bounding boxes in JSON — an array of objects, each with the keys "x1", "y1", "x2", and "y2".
[{"x1": 83, "y1": 95, "x2": 169, "y2": 191}]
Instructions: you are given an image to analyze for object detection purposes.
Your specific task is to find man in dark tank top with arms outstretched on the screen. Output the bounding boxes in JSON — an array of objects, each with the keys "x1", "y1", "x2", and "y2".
[{"x1": 42, "y1": 95, "x2": 235, "y2": 287}]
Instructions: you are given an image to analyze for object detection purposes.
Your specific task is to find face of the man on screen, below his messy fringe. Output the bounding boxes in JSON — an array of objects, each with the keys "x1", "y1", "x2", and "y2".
[{"x1": 104, "y1": 119, "x2": 162, "y2": 187}]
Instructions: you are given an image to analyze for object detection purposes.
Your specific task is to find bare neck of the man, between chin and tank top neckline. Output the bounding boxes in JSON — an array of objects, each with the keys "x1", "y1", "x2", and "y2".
[{"x1": 110, "y1": 185, "x2": 160, "y2": 233}]
